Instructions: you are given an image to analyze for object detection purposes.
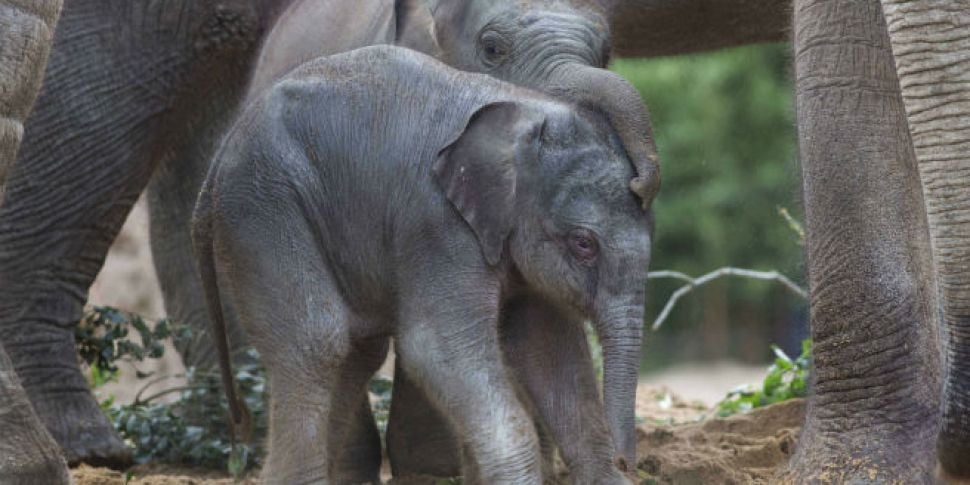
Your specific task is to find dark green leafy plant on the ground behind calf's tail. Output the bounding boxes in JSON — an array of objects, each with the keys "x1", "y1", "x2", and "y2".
[{"x1": 75, "y1": 307, "x2": 392, "y2": 476}]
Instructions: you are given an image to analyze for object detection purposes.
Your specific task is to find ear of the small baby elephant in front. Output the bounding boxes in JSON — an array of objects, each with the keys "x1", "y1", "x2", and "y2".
[{"x1": 434, "y1": 102, "x2": 544, "y2": 265}]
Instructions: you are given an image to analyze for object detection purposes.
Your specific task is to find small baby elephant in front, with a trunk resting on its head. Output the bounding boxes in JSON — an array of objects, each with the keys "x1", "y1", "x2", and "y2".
[{"x1": 193, "y1": 46, "x2": 651, "y2": 484}]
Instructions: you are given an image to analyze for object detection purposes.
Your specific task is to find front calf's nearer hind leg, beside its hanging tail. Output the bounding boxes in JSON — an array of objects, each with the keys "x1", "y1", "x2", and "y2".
[{"x1": 212, "y1": 202, "x2": 374, "y2": 484}]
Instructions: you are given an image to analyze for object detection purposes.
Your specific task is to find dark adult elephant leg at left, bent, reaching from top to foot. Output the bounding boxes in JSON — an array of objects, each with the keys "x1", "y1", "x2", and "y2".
[{"x1": 0, "y1": 0, "x2": 259, "y2": 465}]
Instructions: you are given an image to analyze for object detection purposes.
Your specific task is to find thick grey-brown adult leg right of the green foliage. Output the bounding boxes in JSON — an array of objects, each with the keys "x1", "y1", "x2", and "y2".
[{"x1": 789, "y1": 0, "x2": 941, "y2": 483}]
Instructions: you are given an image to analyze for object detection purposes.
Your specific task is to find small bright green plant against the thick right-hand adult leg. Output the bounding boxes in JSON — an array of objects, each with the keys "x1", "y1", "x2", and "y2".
[{"x1": 717, "y1": 339, "x2": 812, "y2": 418}]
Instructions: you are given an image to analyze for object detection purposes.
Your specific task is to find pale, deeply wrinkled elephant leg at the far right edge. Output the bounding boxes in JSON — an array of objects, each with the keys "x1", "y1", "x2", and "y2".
[{"x1": 882, "y1": 0, "x2": 970, "y2": 477}]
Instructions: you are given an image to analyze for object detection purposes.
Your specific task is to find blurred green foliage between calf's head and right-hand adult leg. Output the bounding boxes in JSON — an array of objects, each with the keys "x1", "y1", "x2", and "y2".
[{"x1": 613, "y1": 45, "x2": 804, "y2": 368}]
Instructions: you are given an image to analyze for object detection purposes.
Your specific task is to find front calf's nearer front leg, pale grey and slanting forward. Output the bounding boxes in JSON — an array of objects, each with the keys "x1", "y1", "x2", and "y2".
[{"x1": 396, "y1": 285, "x2": 542, "y2": 485}]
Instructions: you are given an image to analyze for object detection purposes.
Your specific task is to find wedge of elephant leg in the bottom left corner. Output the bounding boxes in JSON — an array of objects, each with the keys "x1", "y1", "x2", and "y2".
[{"x1": 0, "y1": 346, "x2": 71, "y2": 485}]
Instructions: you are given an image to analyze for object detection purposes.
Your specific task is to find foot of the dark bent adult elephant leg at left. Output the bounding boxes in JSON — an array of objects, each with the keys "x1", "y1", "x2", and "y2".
[{"x1": 33, "y1": 391, "x2": 132, "y2": 470}]
